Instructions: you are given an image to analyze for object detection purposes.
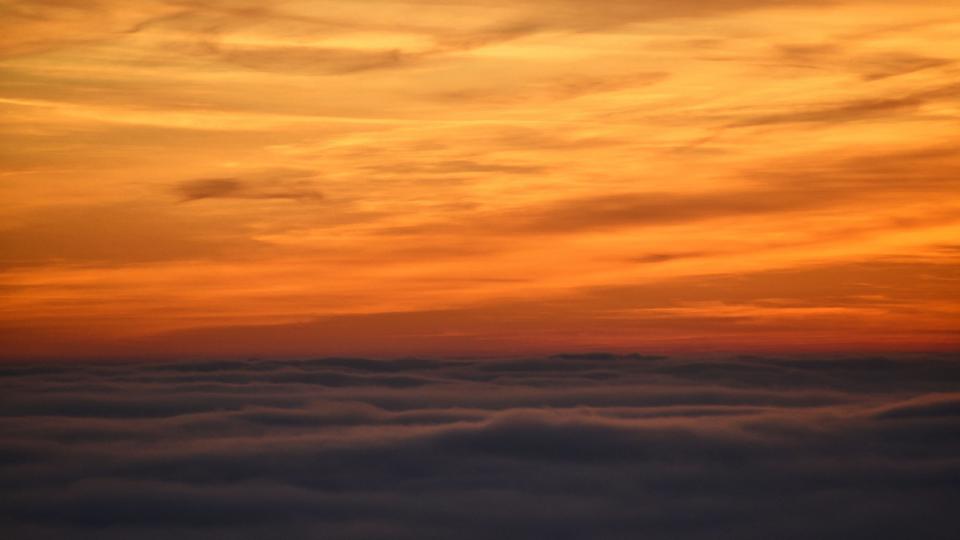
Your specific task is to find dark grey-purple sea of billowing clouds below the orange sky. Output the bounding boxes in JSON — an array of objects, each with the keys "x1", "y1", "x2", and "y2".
[{"x1": 0, "y1": 354, "x2": 960, "y2": 540}]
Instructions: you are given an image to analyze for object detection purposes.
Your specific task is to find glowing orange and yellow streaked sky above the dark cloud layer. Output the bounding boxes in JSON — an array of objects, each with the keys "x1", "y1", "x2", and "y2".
[{"x1": 0, "y1": 0, "x2": 960, "y2": 359}]
